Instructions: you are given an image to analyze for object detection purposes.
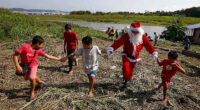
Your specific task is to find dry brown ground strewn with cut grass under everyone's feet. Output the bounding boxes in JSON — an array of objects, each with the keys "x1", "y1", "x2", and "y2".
[{"x1": 0, "y1": 39, "x2": 200, "y2": 110}]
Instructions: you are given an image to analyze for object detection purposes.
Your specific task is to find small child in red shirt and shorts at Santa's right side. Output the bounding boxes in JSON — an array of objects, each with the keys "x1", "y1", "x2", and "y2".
[{"x1": 157, "y1": 51, "x2": 186, "y2": 103}]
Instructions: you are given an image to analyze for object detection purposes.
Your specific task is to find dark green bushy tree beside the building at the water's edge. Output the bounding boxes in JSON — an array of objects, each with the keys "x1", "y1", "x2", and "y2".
[{"x1": 161, "y1": 20, "x2": 185, "y2": 41}]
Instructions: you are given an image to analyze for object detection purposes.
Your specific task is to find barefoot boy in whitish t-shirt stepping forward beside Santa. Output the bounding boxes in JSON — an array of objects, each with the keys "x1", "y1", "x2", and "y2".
[{"x1": 62, "y1": 36, "x2": 105, "y2": 98}]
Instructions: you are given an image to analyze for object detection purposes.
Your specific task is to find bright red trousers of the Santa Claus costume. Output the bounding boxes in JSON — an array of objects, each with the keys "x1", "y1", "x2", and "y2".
[{"x1": 122, "y1": 56, "x2": 137, "y2": 80}]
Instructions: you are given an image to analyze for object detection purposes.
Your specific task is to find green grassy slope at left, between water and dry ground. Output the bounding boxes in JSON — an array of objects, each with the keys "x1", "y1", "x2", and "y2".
[{"x1": 0, "y1": 9, "x2": 105, "y2": 42}]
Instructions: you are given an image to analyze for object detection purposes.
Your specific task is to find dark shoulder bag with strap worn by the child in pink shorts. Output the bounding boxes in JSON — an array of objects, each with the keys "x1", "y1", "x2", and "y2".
[{"x1": 15, "y1": 50, "x2": 37, "y2": 76}]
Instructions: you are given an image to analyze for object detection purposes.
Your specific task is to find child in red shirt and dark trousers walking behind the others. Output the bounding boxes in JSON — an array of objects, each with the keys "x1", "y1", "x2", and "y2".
[{"x1": 64, "y1": 24, "x2": 79, "y2": 74}]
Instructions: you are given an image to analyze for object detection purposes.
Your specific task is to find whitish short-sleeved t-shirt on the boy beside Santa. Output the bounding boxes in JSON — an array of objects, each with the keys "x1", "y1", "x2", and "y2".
[{"x1": 75, "y1": 45, "x2": 101, "y2": 74}]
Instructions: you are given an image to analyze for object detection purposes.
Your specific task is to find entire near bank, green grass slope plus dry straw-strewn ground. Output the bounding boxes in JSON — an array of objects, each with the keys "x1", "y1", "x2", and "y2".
[{"x1": 0, "y1": 10, "x2": 200, "y2": 110}]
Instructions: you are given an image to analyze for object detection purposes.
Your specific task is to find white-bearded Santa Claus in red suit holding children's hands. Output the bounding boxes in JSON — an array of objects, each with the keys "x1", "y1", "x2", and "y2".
[{"x1": 107, "y1": 22, "x2": 158, "y2": 88}]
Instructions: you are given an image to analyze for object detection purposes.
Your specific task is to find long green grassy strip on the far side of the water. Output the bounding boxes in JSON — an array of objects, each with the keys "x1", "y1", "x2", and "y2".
[{"x1": 33, "y1": 14, "x2": 200, "y2": 26}]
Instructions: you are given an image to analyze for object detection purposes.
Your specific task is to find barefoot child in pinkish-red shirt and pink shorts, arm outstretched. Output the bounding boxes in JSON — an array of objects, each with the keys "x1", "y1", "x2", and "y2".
[{"x1": 13, "y1": 36, "x2": 60, "y2": 99}]
